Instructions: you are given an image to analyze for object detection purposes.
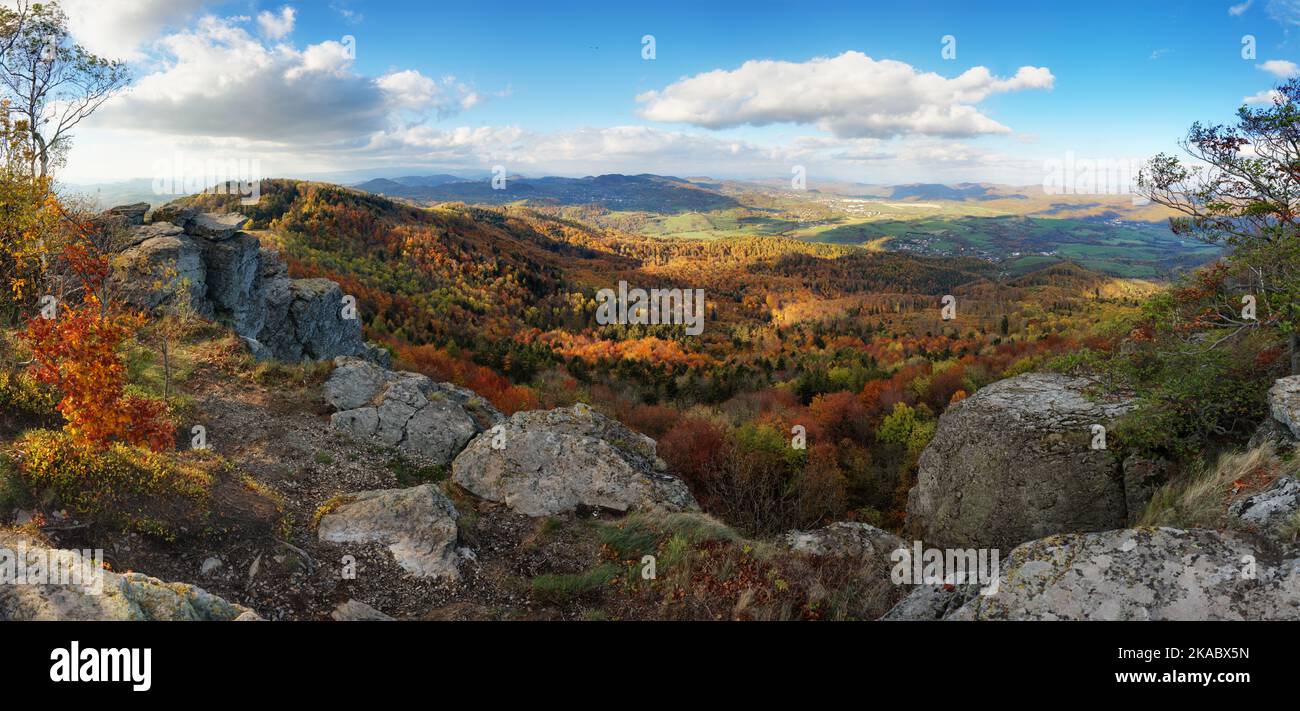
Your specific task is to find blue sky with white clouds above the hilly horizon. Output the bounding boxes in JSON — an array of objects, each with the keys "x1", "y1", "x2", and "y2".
[{"x1": 32, "y1": 0, "x2": 1300, "y2": 186}]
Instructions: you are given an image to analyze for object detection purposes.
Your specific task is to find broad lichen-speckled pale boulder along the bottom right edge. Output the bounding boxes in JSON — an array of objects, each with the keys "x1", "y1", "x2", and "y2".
[{"x1": 946, "y1": 528, "x2": 1300, "y2": 620}]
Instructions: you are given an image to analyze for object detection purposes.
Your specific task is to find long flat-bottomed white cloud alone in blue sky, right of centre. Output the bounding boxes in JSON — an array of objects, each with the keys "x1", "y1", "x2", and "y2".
[{"x1": 637, "y1": 52, "x2": 1054, "y2": 138}]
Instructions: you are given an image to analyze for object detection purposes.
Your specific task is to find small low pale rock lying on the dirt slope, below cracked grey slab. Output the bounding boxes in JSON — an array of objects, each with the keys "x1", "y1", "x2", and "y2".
[{"x1": 316, "y1": 484, "x2": 460, "y2": 581}]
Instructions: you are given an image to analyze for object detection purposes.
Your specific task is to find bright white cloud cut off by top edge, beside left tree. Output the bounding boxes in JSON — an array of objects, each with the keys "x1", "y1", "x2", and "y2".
[{"x1": 60, "y1": 0, "x2": 207, "y2": 60}]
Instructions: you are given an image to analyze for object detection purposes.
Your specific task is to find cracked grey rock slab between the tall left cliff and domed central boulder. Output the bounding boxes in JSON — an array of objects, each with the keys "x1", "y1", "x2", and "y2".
[{"x1": 325, "y1": 357, "x2": 504, "y2": 465}]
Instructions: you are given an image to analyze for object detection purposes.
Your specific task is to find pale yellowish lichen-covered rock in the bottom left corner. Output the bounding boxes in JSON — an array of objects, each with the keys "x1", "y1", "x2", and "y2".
[{"x1": 0, "y1": 530, "x2": 261, "y2": 620}]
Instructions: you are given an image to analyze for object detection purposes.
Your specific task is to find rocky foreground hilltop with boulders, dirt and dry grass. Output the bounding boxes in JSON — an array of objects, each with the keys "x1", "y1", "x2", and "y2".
[{"x1": 10, "y1": 211, "x2": 1300, "y2": 620}]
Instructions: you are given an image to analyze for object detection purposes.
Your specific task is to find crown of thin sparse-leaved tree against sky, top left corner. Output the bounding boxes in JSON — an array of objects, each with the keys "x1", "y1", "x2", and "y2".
[{"x1": 0, "y1": 3, "x2": 130, "y2": 177}]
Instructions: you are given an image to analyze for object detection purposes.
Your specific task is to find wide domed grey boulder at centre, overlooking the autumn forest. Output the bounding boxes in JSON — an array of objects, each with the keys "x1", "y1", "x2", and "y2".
[{"x1": 451, "y1": 406, "x2": 698, "y2": 516}]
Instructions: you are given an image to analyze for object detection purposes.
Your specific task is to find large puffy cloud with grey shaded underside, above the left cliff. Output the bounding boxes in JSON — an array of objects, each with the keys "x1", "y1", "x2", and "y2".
[{"x1": 95, "y1": 16, "x2": 477, "y2": 144}]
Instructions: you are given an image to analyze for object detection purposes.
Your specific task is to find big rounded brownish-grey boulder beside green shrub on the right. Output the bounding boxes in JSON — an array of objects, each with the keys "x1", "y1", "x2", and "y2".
[{"x1": 907, "y1": 373, "x2": 1138, "y2": 549}]
